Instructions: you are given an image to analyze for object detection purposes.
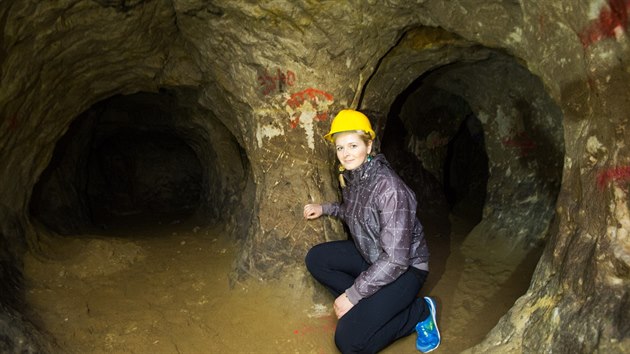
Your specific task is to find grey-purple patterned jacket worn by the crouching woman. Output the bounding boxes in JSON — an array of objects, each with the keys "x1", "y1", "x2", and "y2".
[{"x1": 322, "y1": 154, "x2": 429, "y2": 304}]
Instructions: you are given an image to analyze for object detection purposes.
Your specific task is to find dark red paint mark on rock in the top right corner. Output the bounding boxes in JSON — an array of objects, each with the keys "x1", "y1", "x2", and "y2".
[{"x1": 579, "y1": 0, "x2": 630, "y2": 48}]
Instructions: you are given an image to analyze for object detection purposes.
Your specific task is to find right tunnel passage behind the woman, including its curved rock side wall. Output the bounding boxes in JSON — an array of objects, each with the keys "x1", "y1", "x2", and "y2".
[{"x1": 381, "y1": 48, "x2": 564, "y2": 248}]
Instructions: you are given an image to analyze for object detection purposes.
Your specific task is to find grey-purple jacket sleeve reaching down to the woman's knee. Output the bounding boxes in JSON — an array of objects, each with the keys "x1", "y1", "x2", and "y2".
[{"x1": 346, "y1": 183, "x2": 416, "y2": 304}]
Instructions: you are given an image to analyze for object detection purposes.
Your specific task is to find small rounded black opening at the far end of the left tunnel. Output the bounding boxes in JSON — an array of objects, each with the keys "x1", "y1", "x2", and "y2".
[{"x1": 85, "y1": 130, "x2": 203, "y2": 227}]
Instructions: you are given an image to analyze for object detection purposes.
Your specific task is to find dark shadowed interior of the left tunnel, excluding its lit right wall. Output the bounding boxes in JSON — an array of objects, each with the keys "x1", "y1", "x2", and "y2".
[{"x1": 30, "y1": 93, "x2": 207, "y2": 234}]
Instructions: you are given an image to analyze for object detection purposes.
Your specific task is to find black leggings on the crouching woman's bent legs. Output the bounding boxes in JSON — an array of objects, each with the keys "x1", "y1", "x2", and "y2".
[{"x1": 306, "y1": 241, "x2": 429, "y2": 353}]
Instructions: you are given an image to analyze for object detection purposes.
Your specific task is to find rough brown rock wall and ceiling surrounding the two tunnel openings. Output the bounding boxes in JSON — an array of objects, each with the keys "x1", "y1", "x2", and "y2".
[{"x1": 0, "y1": 0, "x2": 630, "y2": 352}]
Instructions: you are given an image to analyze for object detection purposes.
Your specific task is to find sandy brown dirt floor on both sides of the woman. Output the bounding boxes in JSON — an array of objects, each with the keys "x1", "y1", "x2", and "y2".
[{"x1": 25, "y1": 216, "x2": 540, "y2": 354}]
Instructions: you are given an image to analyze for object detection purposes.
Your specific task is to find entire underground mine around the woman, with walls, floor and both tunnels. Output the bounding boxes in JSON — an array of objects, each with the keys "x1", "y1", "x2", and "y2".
[{"x1": 0, "y1": 0, "x2": 630, "y2": 353}]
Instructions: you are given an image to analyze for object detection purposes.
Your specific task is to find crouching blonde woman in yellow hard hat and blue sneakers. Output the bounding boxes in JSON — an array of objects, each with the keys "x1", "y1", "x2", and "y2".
[{"x1": 304, "y1": 109, "x2": 440, "y2": 353}]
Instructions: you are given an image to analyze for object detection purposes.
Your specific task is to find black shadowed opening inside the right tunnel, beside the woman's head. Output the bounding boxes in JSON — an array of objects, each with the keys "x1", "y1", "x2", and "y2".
[{"x1": 381, "y1": 69, "x2": 489, "y2": 235}]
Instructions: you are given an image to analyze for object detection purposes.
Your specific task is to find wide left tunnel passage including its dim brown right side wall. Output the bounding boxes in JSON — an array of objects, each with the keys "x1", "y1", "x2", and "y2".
[{"x1": 30, "y1": 90, "x2": 253, "y2": 234}]
